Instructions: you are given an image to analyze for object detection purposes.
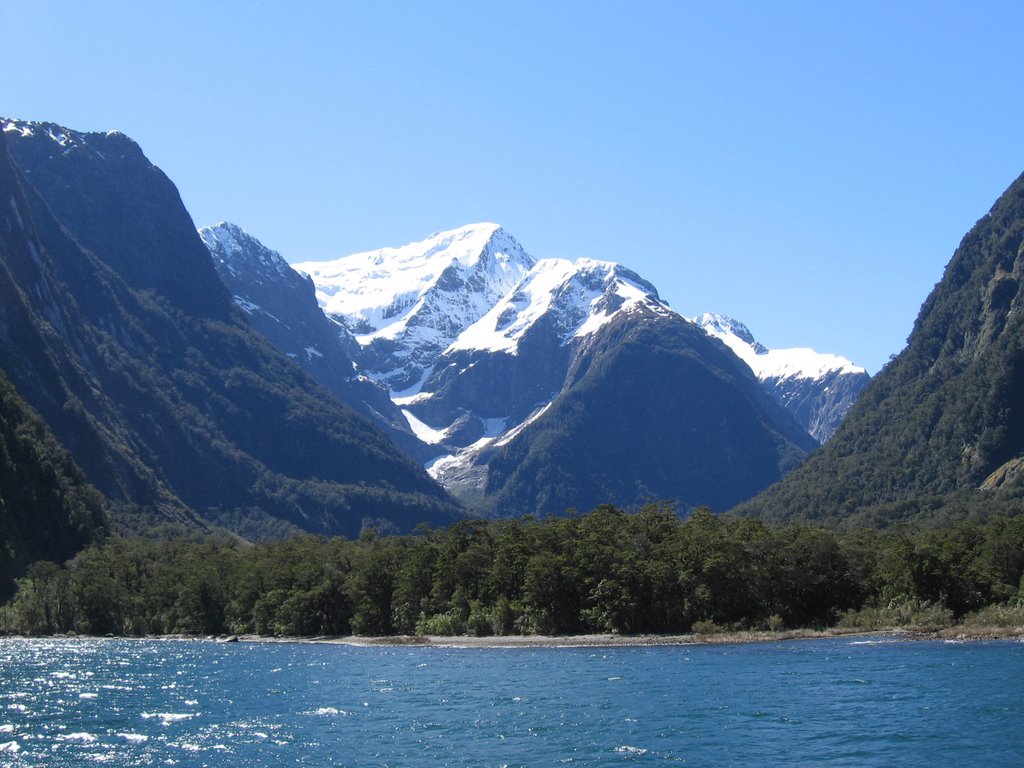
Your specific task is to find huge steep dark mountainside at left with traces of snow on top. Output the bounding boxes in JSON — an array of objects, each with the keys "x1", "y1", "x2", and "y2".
[{"x1": 0, "y1": 120, "x2": 456, "y2": 536}]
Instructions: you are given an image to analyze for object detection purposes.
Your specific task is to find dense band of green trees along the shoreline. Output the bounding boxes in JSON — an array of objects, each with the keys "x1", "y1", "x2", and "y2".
[{"x1": 0, "y1": 505, "x2": 1024, "y2": 636}]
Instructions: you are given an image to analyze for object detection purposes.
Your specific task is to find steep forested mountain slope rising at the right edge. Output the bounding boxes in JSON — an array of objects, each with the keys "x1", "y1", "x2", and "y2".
[{"x1": 739, "y1": 171, "x2": 1024, "y2": 522}]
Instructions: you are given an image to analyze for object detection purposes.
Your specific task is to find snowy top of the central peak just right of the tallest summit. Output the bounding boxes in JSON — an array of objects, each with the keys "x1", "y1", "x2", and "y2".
[{"x1": 449, "y1": 259, "x2": 672, "y2": 354}]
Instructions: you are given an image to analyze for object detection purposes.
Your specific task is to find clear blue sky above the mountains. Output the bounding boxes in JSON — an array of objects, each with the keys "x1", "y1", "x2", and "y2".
[{"x1": 6, "y1": 0, "x2": 1024, "y2": 373}]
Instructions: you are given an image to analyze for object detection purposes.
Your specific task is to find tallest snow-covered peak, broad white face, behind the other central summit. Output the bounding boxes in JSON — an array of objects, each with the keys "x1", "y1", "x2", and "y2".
[{"x1": 295, "y1": 223, "x2": 534, "y2": 391}]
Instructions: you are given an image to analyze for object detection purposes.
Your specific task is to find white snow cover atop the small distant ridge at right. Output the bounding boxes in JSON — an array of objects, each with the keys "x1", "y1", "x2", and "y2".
[{"x1": 694, "y1": 312, "x2": 866, "y2": 381}]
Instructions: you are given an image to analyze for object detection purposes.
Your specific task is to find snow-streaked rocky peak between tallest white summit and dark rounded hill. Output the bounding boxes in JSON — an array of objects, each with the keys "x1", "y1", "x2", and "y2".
[{"x1": 403, "y1": 259, "x2": 674, "y2": 462}]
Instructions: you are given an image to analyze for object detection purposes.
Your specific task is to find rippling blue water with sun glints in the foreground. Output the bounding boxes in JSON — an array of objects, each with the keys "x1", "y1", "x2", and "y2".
[{"x1": 0, "y1": 639, "x2": 1024, "y2": 768}]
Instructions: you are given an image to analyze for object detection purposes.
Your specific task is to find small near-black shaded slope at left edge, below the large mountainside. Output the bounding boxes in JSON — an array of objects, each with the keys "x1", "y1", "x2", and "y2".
[{"x1": 0, "y1": 372, "x2": 106, "y2": 599}]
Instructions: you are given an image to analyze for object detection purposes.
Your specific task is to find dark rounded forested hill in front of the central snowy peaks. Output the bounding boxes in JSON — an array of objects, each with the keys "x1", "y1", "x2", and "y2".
[{"x1": 486, "y1": 312, "x2": 816, "y2": 514}]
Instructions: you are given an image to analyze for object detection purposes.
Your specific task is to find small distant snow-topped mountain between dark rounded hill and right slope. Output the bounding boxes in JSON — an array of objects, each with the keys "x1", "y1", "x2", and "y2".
[{"x1": 696, "y1": 313, "x2": 870, "y2": 442}]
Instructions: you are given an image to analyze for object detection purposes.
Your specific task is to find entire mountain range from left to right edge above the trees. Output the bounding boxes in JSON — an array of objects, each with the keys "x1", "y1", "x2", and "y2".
[{"x1": 14, "y1": 112, "x2": 1024, "y2": 572}]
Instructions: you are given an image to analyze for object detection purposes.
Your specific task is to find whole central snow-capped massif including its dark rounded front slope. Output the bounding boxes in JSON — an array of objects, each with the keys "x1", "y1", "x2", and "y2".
[{"x1": 282, "y1": 224, "x2": 814, "y2": 514}]
